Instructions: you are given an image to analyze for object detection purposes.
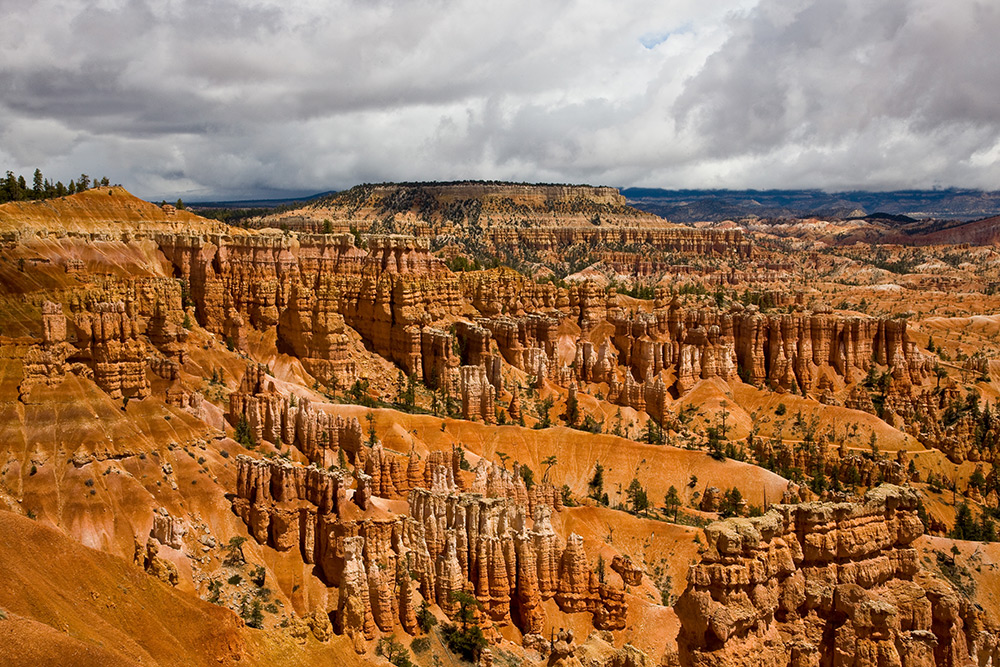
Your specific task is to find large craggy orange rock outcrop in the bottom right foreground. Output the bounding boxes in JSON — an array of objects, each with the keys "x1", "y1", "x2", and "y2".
[{"x1": 675, "y1": 485, "x2": 995, "y2": 666}]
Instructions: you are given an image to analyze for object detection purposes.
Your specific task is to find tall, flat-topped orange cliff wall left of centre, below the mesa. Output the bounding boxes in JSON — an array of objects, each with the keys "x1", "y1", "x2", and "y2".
[{"x1": 157, "y1": 233, "x2": 459, "y2": 386}]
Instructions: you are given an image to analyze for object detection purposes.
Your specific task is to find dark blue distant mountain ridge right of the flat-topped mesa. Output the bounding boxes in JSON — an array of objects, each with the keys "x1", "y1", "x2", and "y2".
[{"x1": 621, "y1": 188, "x2": 1000, "y2": 222}]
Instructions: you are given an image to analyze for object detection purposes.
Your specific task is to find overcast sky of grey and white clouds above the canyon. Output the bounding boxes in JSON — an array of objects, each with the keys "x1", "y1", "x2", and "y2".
[{"x1": 0, "y1": 0, "x2": 1000, "y2": 201}]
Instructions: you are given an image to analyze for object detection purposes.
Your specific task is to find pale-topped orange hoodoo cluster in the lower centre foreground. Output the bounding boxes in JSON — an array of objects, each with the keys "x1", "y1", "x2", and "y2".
[{"x1": 233, "y1": 456, "x2": 627, "y2": 646}]
